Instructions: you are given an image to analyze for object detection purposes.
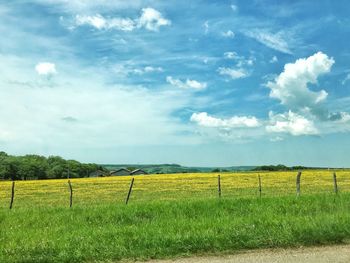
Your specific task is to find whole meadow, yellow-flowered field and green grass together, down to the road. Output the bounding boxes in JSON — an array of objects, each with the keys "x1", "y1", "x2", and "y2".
[{"x1": 0, "y1": 170, "x2": 350, "y2": 262}]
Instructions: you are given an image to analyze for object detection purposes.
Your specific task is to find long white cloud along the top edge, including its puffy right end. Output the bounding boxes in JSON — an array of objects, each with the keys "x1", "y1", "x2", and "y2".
[{"x1": 75, "y1": 7, "x2": 171, "y2": 31}]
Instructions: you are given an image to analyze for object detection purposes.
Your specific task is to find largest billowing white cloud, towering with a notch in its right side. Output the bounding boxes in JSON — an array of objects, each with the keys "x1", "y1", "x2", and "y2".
[{"x1": 267, "y1": 52, "x2": 334, "y2": 109}]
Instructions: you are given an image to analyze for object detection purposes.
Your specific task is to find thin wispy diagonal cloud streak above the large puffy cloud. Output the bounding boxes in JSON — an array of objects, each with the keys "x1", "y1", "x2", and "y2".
[{"x1": 245, "y1": 30, "x2": 292, "y2": 54}]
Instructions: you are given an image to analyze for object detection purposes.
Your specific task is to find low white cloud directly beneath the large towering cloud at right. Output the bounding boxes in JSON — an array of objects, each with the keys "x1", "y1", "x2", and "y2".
[{"x1": 266, "y1": 111, "x2": 319, "y2": 136}]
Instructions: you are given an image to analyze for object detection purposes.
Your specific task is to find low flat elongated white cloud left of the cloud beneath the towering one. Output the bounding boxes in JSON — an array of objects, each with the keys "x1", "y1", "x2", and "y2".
[{"x1": 190, "y1": 112, "x2": 260, "y2": 128}]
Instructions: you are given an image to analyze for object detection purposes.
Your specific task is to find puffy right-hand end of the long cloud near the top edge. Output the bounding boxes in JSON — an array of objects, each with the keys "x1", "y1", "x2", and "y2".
[{"x1": 138, "y1": 7, "x2": 171, "y2": 31}]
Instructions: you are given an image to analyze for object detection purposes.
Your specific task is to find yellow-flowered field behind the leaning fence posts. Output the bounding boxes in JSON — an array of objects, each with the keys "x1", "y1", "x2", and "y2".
[{"x1": 0, "y1": 170, "x2": 350, "y2": 208}]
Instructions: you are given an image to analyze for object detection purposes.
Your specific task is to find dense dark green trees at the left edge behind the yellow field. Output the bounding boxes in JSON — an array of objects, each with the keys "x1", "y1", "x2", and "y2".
[{"x1": 0, "y1": 152, "x2": 105, "y2": 180}]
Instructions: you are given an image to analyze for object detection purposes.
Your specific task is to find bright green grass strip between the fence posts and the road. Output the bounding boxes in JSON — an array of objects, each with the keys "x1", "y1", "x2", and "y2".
[{"x1": 0, "y1": 193, "x2": 350, "y2": 262}]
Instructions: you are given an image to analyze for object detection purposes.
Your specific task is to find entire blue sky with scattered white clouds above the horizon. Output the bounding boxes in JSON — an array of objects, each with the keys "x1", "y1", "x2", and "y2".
[{"x1": 0, "y1": 0, "x2": 350, "y2": 167}]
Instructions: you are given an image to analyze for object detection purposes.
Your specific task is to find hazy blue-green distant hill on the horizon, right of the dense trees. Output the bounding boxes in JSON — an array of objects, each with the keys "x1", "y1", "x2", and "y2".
[{"x1": 101, "y1": 164, "x2": 256, "y2": 174}]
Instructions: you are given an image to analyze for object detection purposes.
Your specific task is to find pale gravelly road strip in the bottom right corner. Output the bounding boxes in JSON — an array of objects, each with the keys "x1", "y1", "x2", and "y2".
[{"x1": 151, "y1": 245, "x2": 350, "y2": 263}]
